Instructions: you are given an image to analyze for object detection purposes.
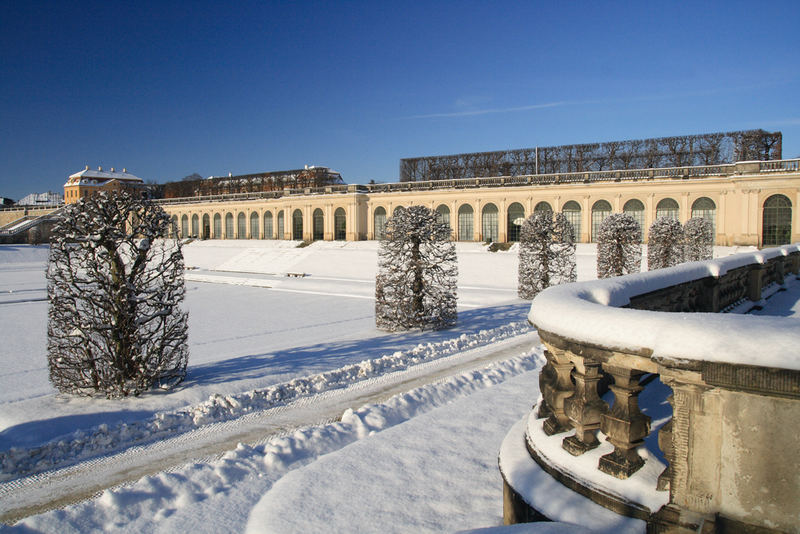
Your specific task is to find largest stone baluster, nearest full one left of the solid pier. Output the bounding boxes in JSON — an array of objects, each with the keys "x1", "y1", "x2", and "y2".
[{"x1": 598, "y1": 364, "x2": 650, "y2": 479}]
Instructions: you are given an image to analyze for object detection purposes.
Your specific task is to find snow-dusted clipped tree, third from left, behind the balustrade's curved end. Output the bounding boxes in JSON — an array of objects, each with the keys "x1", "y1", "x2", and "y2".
[{"x1": 517, "y1": 211, "x2": 578, "y2": 300}]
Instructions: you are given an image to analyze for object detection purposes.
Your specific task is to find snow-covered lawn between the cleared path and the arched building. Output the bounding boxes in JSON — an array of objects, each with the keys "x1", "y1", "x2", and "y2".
[{"x1": 0, "y1": 241, "x2": 527, "y2": 452}]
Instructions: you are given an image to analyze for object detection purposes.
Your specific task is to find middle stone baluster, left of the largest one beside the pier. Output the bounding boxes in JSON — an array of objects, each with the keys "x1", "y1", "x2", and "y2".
[{"x1": 561, "y1": 356, "x2": 608, "y2": 456}]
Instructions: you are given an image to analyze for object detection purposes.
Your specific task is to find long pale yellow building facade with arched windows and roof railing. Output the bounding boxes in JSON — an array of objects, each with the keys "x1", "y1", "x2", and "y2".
[{"x1": 153, "y1": 160, "x2": 800, "y2": 246}]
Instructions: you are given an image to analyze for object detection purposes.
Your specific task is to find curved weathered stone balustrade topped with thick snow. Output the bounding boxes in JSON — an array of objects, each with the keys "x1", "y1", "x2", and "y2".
[{"x1": 500, "y1": 245, "x2": 800, "y2": 532}]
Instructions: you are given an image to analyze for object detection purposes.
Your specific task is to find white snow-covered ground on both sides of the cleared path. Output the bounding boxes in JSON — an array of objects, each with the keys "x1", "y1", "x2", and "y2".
[{"x1": 0, "y1": 241, "x2": 780, "y2": 533}]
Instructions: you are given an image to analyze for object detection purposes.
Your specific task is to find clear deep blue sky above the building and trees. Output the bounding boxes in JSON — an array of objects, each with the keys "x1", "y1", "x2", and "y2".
[{"x1": 0, "y1": 0, "x2": 800, "y2": 199}]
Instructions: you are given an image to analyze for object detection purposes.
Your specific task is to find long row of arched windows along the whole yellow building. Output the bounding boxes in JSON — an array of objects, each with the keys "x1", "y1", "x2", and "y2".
[{"x1": 162, "y1": 194, "x2": 793, "y2": 246}]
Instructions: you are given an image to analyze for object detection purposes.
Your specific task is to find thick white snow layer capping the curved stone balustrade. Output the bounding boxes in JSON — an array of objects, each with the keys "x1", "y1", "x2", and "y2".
[{"x1": 528, "y1": 245, "x2": 800, "y2": 370}]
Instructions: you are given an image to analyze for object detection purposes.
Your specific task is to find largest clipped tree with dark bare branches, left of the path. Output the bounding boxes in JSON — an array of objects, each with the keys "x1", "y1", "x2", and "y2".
[{"x1": 47, "y1": 192, "x2": 188, "y2": 397}]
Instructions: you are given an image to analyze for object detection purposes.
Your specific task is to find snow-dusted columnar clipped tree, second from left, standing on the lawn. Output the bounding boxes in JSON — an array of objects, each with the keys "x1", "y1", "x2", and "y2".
[{"x1": 375, "y1": 206, "x2": 458, "y2": 330}]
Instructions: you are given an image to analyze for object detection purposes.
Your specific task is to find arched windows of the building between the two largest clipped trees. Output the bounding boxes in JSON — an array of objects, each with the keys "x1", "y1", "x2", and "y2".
[{"x1": 172, "y1": 208, "x2": 347, "y2": 241}]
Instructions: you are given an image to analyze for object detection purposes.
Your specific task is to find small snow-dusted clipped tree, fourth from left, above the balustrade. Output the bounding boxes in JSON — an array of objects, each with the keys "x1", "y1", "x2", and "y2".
[{"x1": 597, "y1": 213, "x2": 642, "y2": 278}]
